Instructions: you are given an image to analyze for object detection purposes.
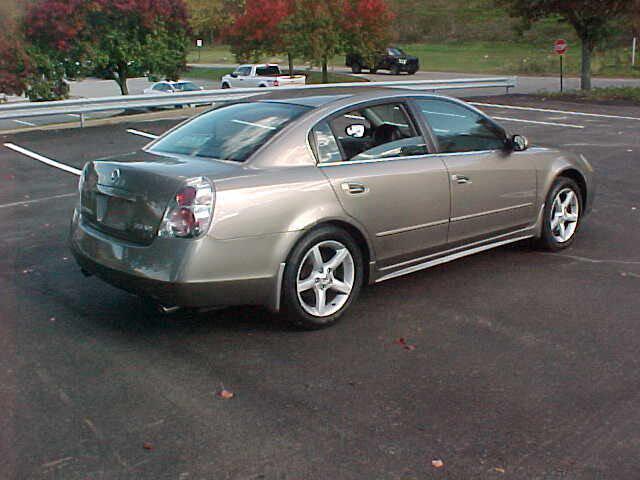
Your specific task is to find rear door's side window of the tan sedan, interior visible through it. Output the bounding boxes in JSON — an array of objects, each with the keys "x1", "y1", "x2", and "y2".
[{"x1": 314, "y1": 103, "x2": 428, "y2": 162}]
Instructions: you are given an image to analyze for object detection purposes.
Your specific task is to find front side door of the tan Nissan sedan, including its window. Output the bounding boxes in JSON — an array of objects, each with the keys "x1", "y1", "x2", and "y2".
[{"x1": 416, "y1": 98, "x2": 537, "y2": 243}]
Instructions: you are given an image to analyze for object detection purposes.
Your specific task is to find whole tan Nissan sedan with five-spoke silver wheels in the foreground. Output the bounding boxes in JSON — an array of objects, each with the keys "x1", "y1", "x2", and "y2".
[{"x1": 70, "y1": 92, "x2": 595, "y2": 329}]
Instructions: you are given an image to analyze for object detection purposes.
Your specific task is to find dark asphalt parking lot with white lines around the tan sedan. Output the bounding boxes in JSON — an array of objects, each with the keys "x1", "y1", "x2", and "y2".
[{"x1": 0, "y1": 96, "x2": 640, "y2": 480}]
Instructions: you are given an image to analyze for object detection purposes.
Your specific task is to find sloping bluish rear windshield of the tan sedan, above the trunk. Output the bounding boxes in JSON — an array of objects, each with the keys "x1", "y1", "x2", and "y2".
[{"x1": 152, "y1": 102, "x2": 310, "y2": 162}]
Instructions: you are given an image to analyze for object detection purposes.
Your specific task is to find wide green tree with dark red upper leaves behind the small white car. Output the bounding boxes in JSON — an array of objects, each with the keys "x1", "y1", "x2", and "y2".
[{"x1": 25, "y1": 0, "x2": 189, "y2": 95}]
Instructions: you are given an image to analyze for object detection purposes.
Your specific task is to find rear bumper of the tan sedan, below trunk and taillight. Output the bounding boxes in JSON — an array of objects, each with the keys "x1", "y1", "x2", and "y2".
[{"x1": 70, "y1": 211, "x2": 292, "y2": 310}]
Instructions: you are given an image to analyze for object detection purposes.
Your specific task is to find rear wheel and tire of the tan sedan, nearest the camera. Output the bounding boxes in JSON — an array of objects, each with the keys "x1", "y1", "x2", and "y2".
[{"x1": 282, "y1": 226, "x2": 364, "y2": 330}]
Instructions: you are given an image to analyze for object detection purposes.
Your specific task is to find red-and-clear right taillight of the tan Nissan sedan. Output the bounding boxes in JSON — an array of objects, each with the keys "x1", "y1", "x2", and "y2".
[{"x1": 158, "y1": 177, "x2": 215, "y2": 238}]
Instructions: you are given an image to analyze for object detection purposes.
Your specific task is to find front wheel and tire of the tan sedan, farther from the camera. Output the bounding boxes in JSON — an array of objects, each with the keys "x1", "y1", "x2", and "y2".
[{"x1": 536, "y1": 177, "x2": 583, "y2": 252}]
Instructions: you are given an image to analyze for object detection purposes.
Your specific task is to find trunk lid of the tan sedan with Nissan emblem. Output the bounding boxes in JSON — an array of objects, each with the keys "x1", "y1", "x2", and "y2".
[{"x1": 80, "y1": 152, "x2": 238, "y2": 245}]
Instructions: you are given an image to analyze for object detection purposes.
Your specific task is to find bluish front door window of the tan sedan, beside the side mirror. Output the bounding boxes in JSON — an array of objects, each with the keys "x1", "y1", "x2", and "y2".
[{"x1": 416, "y1": 99, "x2": 506, "y2": 153}]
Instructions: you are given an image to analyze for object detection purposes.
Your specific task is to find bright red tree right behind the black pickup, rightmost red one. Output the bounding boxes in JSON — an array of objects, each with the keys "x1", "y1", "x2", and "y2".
[{"x1": 343, "y1": 0, "x2": 394, "y2": 65}]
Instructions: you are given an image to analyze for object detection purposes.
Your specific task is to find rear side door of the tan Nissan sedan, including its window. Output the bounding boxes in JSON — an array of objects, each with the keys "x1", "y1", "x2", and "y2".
[{"x1": 311, "y1": 101, "x2": 450, "y2": 273}]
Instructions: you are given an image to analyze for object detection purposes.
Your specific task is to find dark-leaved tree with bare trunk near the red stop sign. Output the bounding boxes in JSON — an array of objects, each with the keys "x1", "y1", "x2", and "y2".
[{"x1": 496, "y1": 0, "x2": 632, "y2": 90}]
